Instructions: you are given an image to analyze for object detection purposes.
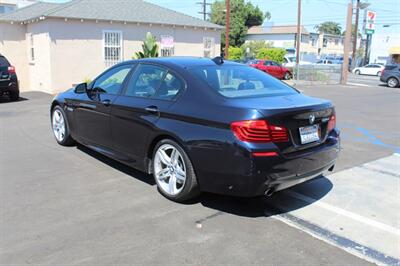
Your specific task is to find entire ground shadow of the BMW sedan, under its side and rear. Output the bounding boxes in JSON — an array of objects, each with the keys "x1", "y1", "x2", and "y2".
[{"x1": 77, "y1": 145, "x2": 333, "y2": 218}]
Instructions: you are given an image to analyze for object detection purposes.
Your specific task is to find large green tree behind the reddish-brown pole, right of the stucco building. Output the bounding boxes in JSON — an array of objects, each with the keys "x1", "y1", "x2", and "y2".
[{"x1": 210, "y1": 0, "x2": 271, "y2": 47}]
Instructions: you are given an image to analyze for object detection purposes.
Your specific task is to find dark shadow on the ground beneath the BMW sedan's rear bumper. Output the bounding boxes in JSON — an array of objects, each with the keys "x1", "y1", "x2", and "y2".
[{"x1": 186, "y1": 176, "x2": 333, "y2": 219}]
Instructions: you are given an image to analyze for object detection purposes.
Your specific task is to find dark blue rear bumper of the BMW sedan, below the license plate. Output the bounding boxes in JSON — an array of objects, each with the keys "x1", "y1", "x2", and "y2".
[{"x1": 197, "y1": 132, "x2": 340, "y2": 197}]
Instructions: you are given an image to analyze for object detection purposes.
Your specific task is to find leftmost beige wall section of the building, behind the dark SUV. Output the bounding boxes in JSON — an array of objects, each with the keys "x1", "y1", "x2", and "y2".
[{"x1": 0, "y1": 22, "x2": 29, "y2": 91}]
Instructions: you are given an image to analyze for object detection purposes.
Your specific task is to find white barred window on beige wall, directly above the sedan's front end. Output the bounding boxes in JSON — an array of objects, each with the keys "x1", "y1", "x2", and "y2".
[{"x1": 103, "y1": 31, "x2": 123, "y2": 67}]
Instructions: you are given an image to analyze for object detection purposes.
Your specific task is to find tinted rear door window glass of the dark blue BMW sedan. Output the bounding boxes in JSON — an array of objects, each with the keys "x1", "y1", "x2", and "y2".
[{"x1": 125, "y1": 65, "x2": 167, "y2": 97}]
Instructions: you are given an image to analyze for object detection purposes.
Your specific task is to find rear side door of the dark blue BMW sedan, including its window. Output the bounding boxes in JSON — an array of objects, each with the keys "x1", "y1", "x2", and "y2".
[{"x1": 111, "y1": 63, "x2": 185, "y2": 168}]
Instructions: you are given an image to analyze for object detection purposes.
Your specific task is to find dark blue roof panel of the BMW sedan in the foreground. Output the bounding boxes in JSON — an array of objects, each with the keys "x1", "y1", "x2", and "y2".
[{"x1": 122, "y1": 56, "x2": 243, "y2": 68}]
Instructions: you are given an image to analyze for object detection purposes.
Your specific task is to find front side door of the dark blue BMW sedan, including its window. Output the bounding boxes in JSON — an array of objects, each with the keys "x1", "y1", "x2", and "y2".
[{"x1": 74, "y1": 64, "x2": 132, "y2": 149}]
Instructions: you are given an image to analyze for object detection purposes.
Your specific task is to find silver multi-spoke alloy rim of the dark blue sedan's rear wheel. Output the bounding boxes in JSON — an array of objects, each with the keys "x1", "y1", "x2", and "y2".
[{"x1": 154, "y1": 144, "x2": 186, "y2": 196}]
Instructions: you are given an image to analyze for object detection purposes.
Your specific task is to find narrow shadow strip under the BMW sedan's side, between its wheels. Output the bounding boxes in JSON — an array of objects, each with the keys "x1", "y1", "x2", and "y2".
[{"x1": 76, "y1": 144, "x2": 156, "y2": 186}]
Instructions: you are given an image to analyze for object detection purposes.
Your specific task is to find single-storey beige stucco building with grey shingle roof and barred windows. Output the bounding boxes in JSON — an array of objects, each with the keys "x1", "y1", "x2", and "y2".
[{"x1": 0, "y1": 0, "x2": 221, "y2": 93}]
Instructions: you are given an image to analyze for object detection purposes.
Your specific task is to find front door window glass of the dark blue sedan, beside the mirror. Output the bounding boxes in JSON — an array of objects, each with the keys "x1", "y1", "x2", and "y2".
[{"x1": 92, "y1": 65, "x2": 132, "y2": 94}]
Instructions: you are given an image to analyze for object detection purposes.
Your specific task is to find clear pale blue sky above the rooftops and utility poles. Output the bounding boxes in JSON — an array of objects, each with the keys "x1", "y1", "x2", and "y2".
[{"x1": 46, "y1": 0, "x2": 400, "y2": 34}]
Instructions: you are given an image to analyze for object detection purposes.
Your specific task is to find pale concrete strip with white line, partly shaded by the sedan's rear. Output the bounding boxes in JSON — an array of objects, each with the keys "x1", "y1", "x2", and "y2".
[{"x1": 267, "y1": 154, "x2": 400, "y2": 265}]
